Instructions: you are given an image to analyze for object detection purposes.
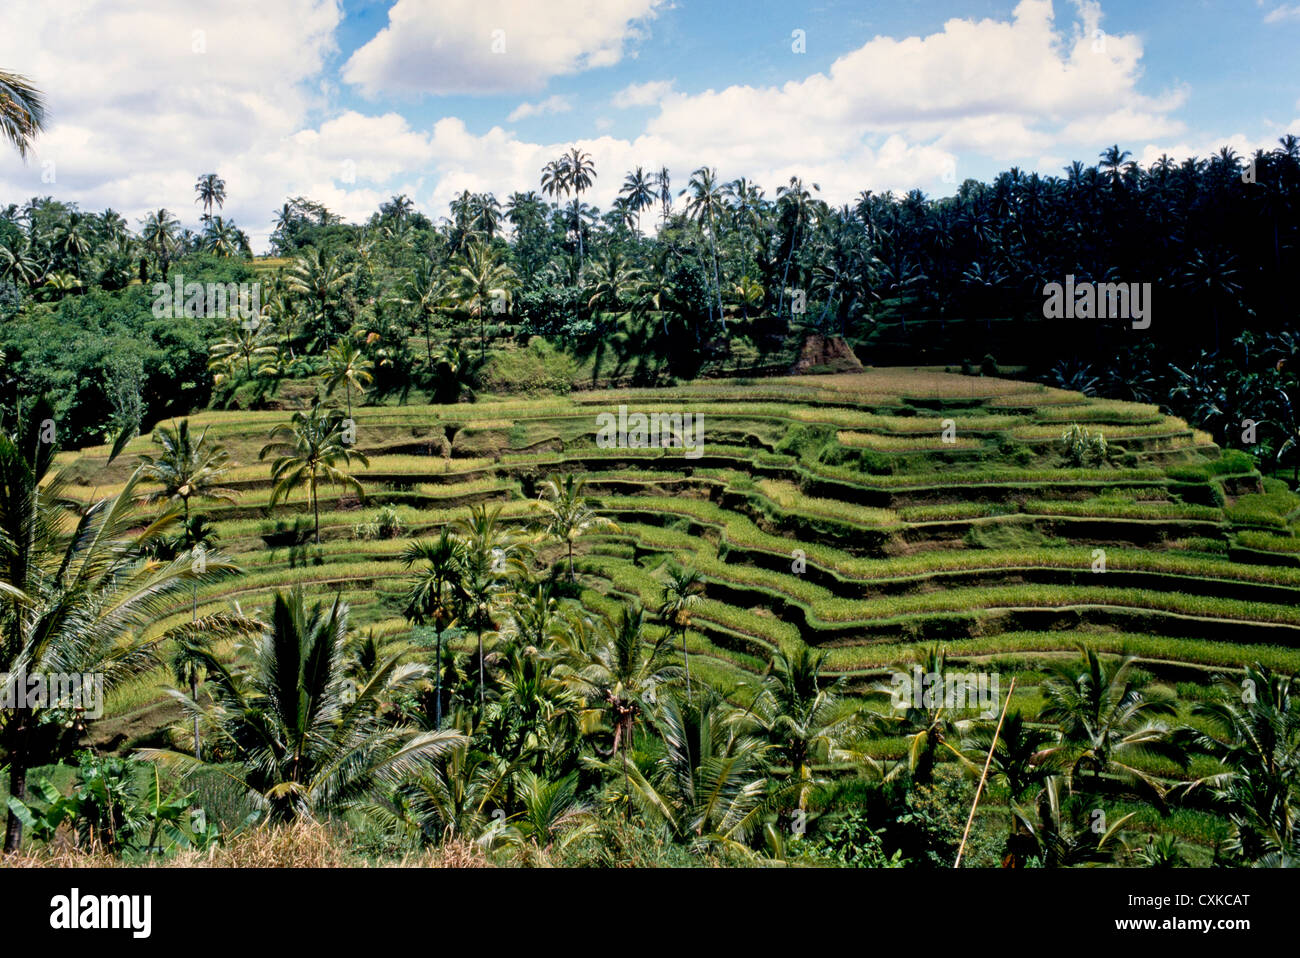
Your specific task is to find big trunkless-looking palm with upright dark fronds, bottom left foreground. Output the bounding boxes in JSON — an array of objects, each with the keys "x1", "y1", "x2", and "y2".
[{"x1": 142, "y1": 591, "x2": 465, "y2": 822}]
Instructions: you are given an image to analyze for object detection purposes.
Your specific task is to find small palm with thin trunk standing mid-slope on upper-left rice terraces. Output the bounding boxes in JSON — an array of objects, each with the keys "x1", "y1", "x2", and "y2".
[{"x1": 257, "y1": 406, "x2": 371, "y2": 546}]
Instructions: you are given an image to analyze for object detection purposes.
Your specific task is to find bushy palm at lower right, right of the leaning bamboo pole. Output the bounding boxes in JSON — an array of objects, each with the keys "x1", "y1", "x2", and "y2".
[{"x1": 1040, "y1": 649, "x2": 1187, "y2": 799}]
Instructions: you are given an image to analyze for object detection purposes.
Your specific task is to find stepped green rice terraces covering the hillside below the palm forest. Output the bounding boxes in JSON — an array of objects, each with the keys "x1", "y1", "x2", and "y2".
[{"x1": 64, "y1": 369, "x2": 1300, "y2": 741}]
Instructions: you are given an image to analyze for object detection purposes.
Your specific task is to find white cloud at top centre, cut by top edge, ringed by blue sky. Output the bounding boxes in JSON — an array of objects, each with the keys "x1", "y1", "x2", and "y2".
[{"x1": 343, "y1": 0, "x2": 663, "y2": 96}]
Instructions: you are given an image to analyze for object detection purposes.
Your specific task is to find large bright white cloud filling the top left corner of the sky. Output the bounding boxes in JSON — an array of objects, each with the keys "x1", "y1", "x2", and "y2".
[{"x1": 0, "y1": 0, "x2": 340, "y2": 246}]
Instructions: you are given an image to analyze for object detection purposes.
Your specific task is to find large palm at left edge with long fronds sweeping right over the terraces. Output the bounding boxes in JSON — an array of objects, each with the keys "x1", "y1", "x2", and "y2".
[{"x1": 0, "y1": 419, "x2": 241, "y2": 853}]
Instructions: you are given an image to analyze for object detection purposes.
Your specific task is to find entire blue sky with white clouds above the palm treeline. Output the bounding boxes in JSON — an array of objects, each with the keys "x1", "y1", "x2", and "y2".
[{"x1": 0, "y1": 0, "x2": 1300, "y2": 246}]
